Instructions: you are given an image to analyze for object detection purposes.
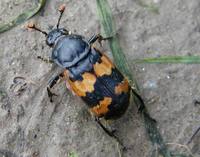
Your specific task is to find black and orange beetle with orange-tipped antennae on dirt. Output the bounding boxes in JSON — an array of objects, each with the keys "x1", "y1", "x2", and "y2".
[{"x1": 28, "y1": 5, "x2": 145, "y2": 147}]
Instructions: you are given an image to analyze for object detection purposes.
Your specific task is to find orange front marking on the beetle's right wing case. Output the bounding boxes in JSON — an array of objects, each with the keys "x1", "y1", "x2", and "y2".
[{"x1": 93, "y1": 55, "x2": 114, "y2": 76}]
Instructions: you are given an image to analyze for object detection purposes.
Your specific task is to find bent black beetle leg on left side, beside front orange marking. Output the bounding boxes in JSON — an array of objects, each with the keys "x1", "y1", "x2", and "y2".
[{"x1": 47, "y1": 72, "x2": 65, "y2": 102}]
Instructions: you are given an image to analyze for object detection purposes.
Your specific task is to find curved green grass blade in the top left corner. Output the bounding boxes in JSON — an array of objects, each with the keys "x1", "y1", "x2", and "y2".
[{"x1": 0, "y1": 0, "x2": 46, "y2": 33}]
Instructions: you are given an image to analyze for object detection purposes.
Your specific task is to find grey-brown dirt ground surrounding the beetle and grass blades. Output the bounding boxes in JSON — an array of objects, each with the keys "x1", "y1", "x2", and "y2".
[{"x1": 0, "y1": 0, "x2": 200, "y2": 157}]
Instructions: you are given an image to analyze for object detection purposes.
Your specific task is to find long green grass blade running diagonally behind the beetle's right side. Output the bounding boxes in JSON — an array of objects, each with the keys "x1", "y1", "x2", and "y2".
[{"x1": 96, "y1": 0, "x2": 188, "y2": 157}]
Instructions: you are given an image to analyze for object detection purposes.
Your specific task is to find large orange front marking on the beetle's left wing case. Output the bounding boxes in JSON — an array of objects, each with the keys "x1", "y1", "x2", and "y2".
[{"x1": 68, "y1": 72, "x2": 96, "y2": 96}]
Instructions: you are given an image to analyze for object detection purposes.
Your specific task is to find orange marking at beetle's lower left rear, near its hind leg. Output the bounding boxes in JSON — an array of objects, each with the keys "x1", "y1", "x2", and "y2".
[{"x1": 90, "y1": 97, "x2": 112, "y2": 116}]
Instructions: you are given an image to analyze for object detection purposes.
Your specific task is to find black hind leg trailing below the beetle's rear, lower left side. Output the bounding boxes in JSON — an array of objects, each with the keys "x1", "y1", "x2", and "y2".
[{"x1": 95, "y1": 117, "x2": 126, "y2": 150}]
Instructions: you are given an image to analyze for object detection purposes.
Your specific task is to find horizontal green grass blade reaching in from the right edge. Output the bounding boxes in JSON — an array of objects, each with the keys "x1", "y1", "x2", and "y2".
[{"x1": 134, "y1": 56, "x2": 200, "y2": 64}]
